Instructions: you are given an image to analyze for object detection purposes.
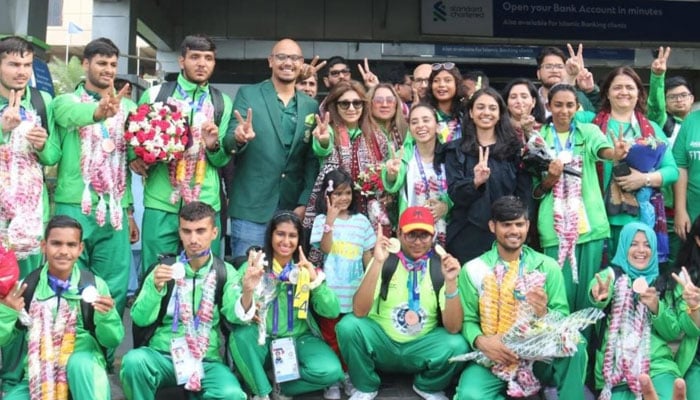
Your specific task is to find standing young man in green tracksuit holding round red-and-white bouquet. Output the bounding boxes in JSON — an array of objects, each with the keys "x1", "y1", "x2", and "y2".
[{"x1": 135, "y1": 35, "x2": 232, "y2": 269}]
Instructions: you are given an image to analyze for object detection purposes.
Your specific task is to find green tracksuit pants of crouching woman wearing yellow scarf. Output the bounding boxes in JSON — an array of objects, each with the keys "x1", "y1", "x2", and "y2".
[{"x1": 230, "y1": 324, "x2": 344, "y2": 396}]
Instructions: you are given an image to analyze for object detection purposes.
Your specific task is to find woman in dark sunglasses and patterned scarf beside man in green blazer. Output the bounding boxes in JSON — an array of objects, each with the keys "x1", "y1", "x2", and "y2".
[{"x1": 304, "y1": 81, "x2": 391, "y2": 263}]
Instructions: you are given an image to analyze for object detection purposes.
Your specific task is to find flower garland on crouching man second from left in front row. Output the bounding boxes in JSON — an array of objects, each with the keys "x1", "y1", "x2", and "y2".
[{"x1": 175, "y1": 268, "x2": 216, "y2": 392}]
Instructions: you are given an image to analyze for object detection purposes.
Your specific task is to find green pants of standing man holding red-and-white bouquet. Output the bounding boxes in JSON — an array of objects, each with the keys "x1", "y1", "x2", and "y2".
[{"x1": 140, "y1": 208, "x2": 221, "y2": 274}]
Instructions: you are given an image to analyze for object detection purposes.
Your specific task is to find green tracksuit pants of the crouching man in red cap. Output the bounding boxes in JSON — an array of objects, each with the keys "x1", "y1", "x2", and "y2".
[{"x1": 335, "y1": 314, "x2": 468, "y2": 393}]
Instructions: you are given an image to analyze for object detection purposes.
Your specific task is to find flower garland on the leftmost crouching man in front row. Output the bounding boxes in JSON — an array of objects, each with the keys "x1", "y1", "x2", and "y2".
[{"x1": 27, "y1": 298, "x2": 78, "y2": 400}]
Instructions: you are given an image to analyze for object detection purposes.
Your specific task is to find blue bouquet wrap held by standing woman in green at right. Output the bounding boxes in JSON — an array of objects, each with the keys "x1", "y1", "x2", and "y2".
[{"x1": 625, "y1": 136, "x2": 670, "y2": 262}]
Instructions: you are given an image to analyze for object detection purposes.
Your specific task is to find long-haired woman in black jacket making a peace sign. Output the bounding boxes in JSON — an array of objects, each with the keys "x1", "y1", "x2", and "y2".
[{"x1": 442, "y1": 88, "x2": 531, "y2": 263}]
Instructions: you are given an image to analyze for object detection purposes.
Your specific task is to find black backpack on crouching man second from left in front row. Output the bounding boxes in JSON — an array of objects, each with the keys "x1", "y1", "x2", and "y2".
[{"x1": 131, "y1": 254, "x2": 233, "y2": 353}]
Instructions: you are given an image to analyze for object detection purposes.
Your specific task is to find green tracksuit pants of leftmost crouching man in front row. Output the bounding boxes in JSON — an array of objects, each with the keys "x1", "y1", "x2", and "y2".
[{"x1": 3, "y1": 351, "x2": 112, "y2": 400}]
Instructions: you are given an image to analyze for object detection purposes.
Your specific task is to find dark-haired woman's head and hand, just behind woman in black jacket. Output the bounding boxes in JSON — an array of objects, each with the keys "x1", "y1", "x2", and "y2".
[{"x1": 501, "y1": 78, "x2": 546, "y2": 143}]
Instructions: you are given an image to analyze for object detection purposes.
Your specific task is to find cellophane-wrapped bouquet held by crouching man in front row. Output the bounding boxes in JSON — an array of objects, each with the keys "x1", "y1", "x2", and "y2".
[{"x1": 450, "y1": 304, "x2": 605, "y2": 397}]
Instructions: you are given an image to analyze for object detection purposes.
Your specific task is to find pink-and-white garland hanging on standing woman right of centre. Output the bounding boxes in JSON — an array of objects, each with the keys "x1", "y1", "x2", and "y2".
[{"x1": 552, "y1": 158, "x2": 583, "y2": 283}]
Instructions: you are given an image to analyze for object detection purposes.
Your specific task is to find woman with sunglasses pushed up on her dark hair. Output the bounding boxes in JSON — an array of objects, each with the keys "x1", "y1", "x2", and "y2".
[{"x1": 425, "y1": 62, "x2": 464, "y2": 143}]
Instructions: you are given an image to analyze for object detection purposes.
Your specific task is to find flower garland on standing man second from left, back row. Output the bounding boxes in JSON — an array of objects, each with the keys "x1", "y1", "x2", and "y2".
[{"x1": 80, "y1": 91, "x2": 126, "y2": 230}]
